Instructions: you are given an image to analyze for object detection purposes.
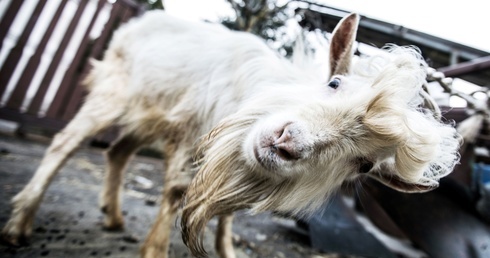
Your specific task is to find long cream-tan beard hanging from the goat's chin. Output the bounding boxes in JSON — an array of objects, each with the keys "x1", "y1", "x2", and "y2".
[{"x1": 181, "y1": 114, "x2": 298, "y2": 257}]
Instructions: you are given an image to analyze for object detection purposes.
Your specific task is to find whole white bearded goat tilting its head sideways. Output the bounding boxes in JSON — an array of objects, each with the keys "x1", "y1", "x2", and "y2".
[{"x1": 3, "y1": 11, "x2": 459, "y2": 257}]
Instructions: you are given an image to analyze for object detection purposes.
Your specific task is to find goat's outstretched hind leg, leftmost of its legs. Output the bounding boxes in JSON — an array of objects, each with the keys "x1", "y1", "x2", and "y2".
[{"x1": 2, "y1": 95, "x2": 119, "y2": 245}]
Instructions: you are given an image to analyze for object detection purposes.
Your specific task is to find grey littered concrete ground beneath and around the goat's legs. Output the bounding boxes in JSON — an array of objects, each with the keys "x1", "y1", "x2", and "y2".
[{"x1": 0, "y1": 134, "x2": 341, "y2": 258}]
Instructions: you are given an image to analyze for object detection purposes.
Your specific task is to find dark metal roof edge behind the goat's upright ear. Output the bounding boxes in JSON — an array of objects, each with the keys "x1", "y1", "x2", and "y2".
[{"x1": 296, "y1": 3, "x2": 490, "y2": 86}]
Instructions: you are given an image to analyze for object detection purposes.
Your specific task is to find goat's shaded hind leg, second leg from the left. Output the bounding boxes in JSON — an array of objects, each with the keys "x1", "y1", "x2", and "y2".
[{"x1": 99, "y1": 134, "x2": 145, "y2": 230}]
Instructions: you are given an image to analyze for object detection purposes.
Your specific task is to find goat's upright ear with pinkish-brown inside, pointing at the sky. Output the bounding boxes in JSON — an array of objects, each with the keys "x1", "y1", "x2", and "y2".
[{"x1": 330, "y1": 13, "x2": 359, "y2": 77}]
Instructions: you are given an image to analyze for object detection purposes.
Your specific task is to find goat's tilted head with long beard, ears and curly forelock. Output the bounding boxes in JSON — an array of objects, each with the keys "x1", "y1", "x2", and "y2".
[{"x1": 181, "y1": 15, "x2": 460, "y2": 256}]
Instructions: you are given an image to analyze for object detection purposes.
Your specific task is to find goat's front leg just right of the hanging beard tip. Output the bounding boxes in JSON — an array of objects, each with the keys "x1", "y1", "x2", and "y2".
[{"x1": 215, "y1": 214, "x2": 236, "y2": 258}]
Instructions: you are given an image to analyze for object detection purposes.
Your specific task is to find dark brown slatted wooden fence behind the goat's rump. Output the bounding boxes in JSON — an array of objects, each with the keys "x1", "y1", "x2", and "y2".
[{"x1": 0, "y1": 0, "x2": 144, "y2": 134}]
